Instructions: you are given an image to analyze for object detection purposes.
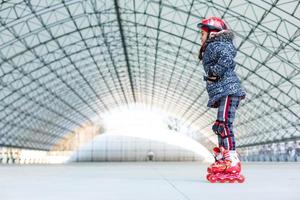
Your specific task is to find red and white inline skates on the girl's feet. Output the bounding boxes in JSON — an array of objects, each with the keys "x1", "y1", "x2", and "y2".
[{"x1": 206, "y1": 149, "x2": 245, "y2": 183}]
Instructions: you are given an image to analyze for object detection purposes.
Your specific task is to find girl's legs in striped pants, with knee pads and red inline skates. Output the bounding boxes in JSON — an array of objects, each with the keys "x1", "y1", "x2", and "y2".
[{"x1": 207, "y1": 96, "x2": 245, "y2": 183}]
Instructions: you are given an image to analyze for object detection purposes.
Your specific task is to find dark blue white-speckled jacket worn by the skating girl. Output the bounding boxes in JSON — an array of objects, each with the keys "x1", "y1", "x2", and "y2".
[{"x1": 202, "y1": 31, "x2": 246, "y2": 107}]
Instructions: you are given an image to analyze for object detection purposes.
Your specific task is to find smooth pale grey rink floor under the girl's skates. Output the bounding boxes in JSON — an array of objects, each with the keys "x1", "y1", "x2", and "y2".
[{"x1": 0, "y1": 162, "x2": 300, "y2": 200}]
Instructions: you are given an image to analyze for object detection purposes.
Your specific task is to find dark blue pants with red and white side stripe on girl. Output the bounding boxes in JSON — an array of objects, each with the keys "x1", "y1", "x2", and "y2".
[{"x1": 218, "y1": 96, "x2": 241, "y2": 150}]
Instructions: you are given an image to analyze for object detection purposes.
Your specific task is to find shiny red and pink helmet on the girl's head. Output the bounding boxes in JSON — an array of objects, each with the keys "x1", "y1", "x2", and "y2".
[{"x1": 197, "y1": 17, "x2": 228, "y2": 32}]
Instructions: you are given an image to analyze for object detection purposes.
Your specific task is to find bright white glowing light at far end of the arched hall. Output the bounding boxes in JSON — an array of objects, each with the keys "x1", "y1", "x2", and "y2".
[{"x1": 97, "y1": 104, "x2": 211, "y2": 162}]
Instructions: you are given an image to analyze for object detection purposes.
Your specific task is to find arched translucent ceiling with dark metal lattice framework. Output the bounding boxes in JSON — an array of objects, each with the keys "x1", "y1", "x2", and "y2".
[{"x1": 0, "y1": 0, "x2": 300, "y2": 150}]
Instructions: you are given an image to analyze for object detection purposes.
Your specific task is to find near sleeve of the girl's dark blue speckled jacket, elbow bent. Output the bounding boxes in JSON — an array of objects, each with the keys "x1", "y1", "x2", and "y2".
[{"x1": 208, "y1": 43, "x2": 236, "y2": 78}]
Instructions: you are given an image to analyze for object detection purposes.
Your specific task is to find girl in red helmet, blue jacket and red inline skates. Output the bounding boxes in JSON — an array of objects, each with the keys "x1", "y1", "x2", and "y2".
[{"x1": 198, "y1": 17, "x2": 246, "y2": 182}]
